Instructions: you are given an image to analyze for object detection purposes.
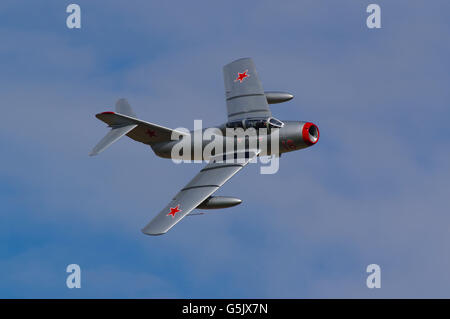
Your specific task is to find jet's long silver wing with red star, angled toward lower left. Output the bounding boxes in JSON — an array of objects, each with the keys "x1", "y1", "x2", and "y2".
[{"x1": 142, "y1": 150, "x2": 259, "y2": 235}]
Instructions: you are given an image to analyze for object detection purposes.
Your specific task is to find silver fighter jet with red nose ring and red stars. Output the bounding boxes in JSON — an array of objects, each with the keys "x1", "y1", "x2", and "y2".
[{"x1": 90, "y1": 58, "x2": 319, "y2": 235}]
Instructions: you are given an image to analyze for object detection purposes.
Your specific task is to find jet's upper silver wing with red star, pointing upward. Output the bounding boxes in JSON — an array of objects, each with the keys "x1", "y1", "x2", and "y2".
[{"x1": 223, "y1": 58, "x2": 272, "y2": 122}]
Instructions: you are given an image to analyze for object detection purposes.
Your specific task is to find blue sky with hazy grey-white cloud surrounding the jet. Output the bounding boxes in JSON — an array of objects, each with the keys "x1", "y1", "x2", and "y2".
[{"x1": 0, "y1": 0, "x2": 450, "y2": 298}]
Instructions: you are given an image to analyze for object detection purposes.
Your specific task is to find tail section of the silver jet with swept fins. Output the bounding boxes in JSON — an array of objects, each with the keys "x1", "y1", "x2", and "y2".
[{"x1": 89, "y1": 99, "x2": 186, "y2": 156}]
